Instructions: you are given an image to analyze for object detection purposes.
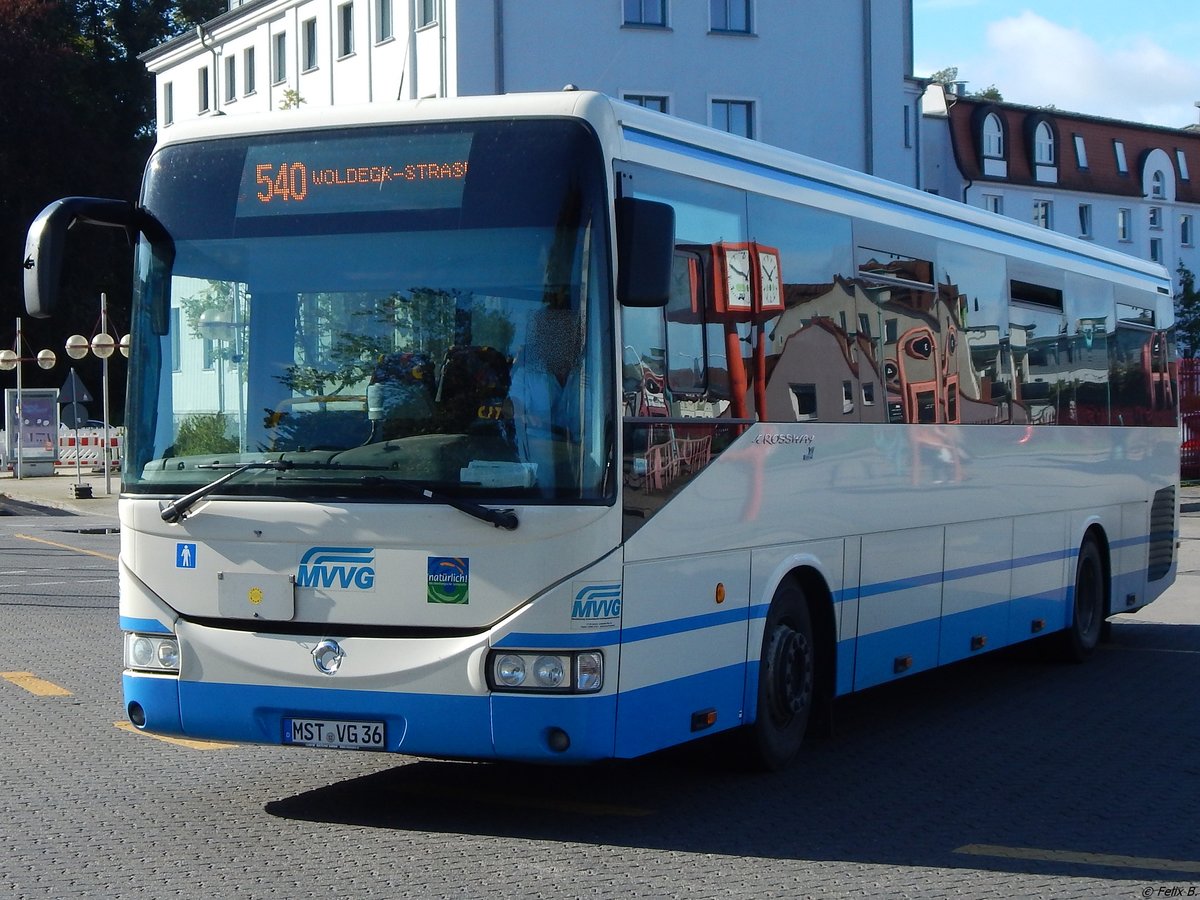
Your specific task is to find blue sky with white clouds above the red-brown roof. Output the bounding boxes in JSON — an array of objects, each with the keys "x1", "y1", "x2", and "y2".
[{"x1": 913, "y1": 0, "x2": 1200, "y2": 127}]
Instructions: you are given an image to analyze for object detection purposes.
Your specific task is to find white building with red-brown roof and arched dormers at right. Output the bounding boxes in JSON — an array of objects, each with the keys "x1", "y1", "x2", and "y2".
[{"x1": 923, "y1": 85, "x2": 1200, "y2": 289}]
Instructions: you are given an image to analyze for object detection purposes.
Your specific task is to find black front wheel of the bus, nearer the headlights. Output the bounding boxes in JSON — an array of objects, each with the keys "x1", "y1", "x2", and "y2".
[{"x1": 748, "y1": 584, "x2": 816, "y2": 772}]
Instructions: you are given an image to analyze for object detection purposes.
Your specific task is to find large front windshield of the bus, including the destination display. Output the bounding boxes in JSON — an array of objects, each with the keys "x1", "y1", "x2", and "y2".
[{"x1": 125, "y1": 121, "x2": 616, "y2": 503}]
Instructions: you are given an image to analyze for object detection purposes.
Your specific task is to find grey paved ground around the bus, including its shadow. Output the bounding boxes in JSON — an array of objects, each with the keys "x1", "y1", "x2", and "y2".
[{"x1": 0, "y1": 494, "x2": 1200, "y2": 899}]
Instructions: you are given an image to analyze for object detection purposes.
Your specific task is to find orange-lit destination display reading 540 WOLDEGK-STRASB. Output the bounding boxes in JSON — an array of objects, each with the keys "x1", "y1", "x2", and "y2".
[{"x1": 236, "y1": 132, "x2": 473, "y2": 218}]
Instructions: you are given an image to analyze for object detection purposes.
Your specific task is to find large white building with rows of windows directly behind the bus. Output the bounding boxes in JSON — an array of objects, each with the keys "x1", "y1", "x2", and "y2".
[{"x1": 142, "y1": 0, "x2": 924, "y2": 186}]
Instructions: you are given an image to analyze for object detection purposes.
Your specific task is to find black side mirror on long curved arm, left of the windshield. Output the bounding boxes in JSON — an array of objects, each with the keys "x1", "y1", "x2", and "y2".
[{"x1": 24, "y1": 197, "x2": 175, "y2": 334}]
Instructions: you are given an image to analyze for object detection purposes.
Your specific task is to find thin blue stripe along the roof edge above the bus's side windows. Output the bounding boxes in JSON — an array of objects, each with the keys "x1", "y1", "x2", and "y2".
[{"x1": 622, "y1": 125, "x2": 1157, "y2": 281}]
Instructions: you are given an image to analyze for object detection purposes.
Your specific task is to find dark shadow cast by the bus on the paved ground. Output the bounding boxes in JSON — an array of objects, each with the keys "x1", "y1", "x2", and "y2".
[{"x1": 266, "y1": 623, "x2": 1200, "y2": 882}]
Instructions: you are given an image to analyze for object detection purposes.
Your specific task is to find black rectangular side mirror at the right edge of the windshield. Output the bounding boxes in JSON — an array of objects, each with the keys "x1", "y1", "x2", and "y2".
[{"x1": 617, "y1": 197, "x2": 674, "y2": 307}]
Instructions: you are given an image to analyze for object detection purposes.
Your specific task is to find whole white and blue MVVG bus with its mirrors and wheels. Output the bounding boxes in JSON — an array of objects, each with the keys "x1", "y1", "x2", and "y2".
[{"x1": 26, "y1": 91, "x2": 1180, "y2": 767}]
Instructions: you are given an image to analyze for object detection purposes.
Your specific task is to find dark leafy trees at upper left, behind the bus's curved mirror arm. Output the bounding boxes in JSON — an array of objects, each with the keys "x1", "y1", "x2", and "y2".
[{"x1": 0, "y1": 0, "x2": 223, "y2": 418}]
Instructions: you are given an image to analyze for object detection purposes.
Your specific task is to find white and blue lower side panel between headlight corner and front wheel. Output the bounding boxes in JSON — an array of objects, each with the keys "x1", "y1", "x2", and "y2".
[{"x1": 617, "y1": 551, "x2": 750, "y2": 757}]
